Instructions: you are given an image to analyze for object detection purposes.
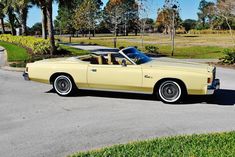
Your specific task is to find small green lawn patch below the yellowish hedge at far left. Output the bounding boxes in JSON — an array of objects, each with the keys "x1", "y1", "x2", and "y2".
[{"x1": 0, "y1": 41, "x2": 29, "y2": 62}]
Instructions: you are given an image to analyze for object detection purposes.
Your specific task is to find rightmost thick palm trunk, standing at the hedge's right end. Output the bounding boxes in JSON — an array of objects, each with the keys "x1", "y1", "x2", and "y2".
[{"x1": 46, "y1": 0, "x2": 56, "y2": 55}]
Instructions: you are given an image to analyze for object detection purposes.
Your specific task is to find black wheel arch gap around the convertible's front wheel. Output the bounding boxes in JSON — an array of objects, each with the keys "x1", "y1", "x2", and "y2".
[{"x1": 153, "y1": 78, "x2": 188, "y2": 94}]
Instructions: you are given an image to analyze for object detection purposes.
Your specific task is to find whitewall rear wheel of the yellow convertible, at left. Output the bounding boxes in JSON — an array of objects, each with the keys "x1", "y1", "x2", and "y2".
[{"x1": 53, "y1": 75, "x2": 76, "y2": 96}]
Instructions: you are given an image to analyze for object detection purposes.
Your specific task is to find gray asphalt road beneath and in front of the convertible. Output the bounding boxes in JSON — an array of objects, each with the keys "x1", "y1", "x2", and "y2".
[{"x1": 0, "y1": 68, "x2": 235, "y2": 157}]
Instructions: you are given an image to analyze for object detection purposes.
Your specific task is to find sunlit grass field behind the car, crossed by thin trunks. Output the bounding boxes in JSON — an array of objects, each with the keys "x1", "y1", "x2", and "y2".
[{"x1": 57, "y1": 35, "x2": 232, "y2": 59}]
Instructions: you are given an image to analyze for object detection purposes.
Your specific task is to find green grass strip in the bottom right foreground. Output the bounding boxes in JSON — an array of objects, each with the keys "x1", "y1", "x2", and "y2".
[{"x1": 69, "y1": 132, "x2": 235, "y2": 157}]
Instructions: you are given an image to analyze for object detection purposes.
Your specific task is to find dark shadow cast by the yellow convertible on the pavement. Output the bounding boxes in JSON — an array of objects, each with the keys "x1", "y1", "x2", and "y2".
[{"x1": 46, "y1": 89, "x2": 235, "y2": 106}]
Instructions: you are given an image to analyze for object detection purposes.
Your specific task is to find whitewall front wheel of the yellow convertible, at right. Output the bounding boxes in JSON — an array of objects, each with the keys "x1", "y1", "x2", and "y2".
[{"x1": 157, "y1": 80, "x2": 184, "y2": 103}]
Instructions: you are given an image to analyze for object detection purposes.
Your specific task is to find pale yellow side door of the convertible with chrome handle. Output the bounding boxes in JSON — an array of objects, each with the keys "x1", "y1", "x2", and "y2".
[{"x1": 87, "y1": 64, "x2": 142, "y2": 91}]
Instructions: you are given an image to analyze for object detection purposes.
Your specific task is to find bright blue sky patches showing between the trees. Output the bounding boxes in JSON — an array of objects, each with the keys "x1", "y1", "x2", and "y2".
[{"x1": 27, "y1": 0, "x2": 213, "y2": 27}]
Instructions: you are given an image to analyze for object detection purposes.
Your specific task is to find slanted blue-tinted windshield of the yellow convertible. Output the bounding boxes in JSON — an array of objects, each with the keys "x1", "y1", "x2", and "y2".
[{"x1": 123, "y1": 48, "x2": 151, "y2": 65}]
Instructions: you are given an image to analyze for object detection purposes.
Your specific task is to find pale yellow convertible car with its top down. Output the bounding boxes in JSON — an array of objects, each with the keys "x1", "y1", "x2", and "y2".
[{"x1": 23, "y1": 47, "x2": 220, "y2": 103}]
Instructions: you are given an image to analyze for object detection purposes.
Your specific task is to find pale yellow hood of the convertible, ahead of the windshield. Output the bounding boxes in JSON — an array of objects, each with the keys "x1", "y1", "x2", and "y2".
[{"x1": 144, "y1": 58, "x2": 214, "y2": 72}]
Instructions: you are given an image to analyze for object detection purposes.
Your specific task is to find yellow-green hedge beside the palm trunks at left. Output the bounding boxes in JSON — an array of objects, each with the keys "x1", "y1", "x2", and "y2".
[{"x1": 0, "y1": 34, "x2": 50, "y2": 54}]
